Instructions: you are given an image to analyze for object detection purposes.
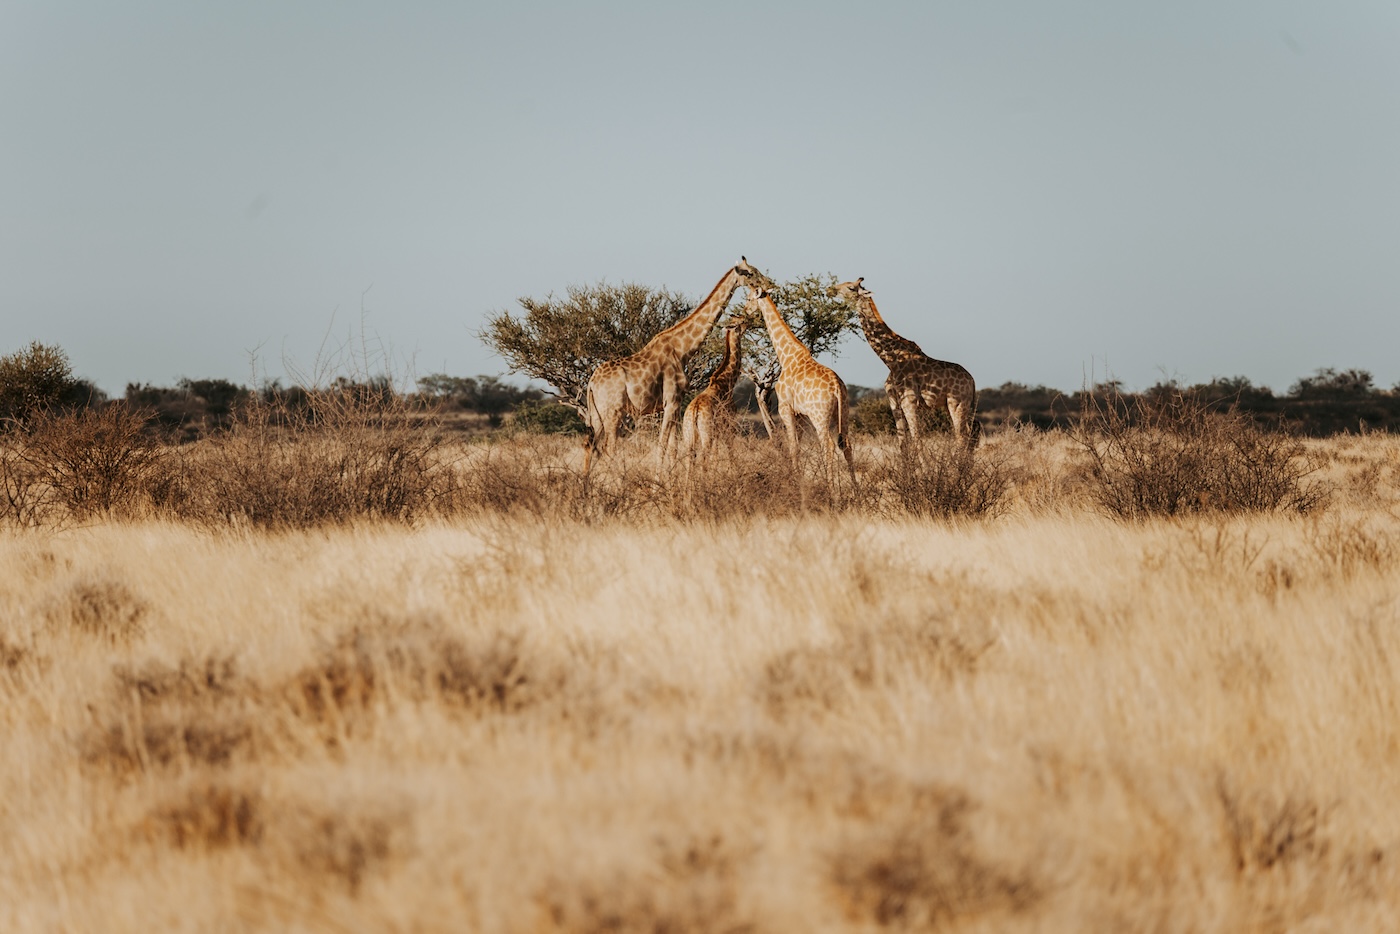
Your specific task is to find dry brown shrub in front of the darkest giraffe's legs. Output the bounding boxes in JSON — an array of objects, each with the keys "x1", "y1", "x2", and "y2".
[{"x1": 867, "y1": 435, "x2": 1012, "y2": 518}]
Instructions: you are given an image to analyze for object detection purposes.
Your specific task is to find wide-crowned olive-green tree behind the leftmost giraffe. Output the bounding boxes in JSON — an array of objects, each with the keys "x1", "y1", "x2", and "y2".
[{"x1": 477, "y1": 283, "x2": 694, "y2": 414}]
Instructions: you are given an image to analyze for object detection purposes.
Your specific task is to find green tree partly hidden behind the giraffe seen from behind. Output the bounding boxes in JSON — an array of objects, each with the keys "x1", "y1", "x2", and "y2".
[{"x1": 743, "y1": 273, "x2": 860, "y2": 437}]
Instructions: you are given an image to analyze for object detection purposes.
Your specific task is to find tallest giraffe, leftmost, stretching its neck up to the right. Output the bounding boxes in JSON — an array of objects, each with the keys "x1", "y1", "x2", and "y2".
[{"x1": 584, "y1": 256, "x2": 773, "y2": 476}]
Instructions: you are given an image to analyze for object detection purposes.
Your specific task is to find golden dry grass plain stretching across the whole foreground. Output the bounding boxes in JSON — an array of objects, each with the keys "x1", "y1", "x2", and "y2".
[{"x1": 0, "y1": 431, "x2": 1400, "y2": 933}]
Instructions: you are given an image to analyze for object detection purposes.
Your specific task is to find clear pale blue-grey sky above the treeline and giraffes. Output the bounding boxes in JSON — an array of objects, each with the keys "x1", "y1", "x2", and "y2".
[{"x1": 0, "y1": 0, "x2": 1400, "y2": 393}]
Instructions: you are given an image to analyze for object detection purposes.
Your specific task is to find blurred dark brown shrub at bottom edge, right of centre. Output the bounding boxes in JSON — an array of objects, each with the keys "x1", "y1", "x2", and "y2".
[{"x1": 832, "y1": 787, "x2": 1039, "y2": 930}]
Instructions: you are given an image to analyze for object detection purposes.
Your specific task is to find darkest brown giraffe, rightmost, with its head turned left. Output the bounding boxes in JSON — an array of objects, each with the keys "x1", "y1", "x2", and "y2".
[{"x1": 832, "y1": 276, "x2": 981, "y2": 451}]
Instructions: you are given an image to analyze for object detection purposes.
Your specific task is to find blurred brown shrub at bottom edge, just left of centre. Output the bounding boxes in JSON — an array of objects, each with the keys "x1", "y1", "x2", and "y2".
[{"x1": 539, "y1": 833, "x2": 757, "y2": 934}]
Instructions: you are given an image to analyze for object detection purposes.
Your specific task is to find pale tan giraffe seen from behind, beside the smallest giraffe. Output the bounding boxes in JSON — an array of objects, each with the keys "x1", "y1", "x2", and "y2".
[{"x1": 743, "y1": 288, "x2": 855, "y2": 486}]
